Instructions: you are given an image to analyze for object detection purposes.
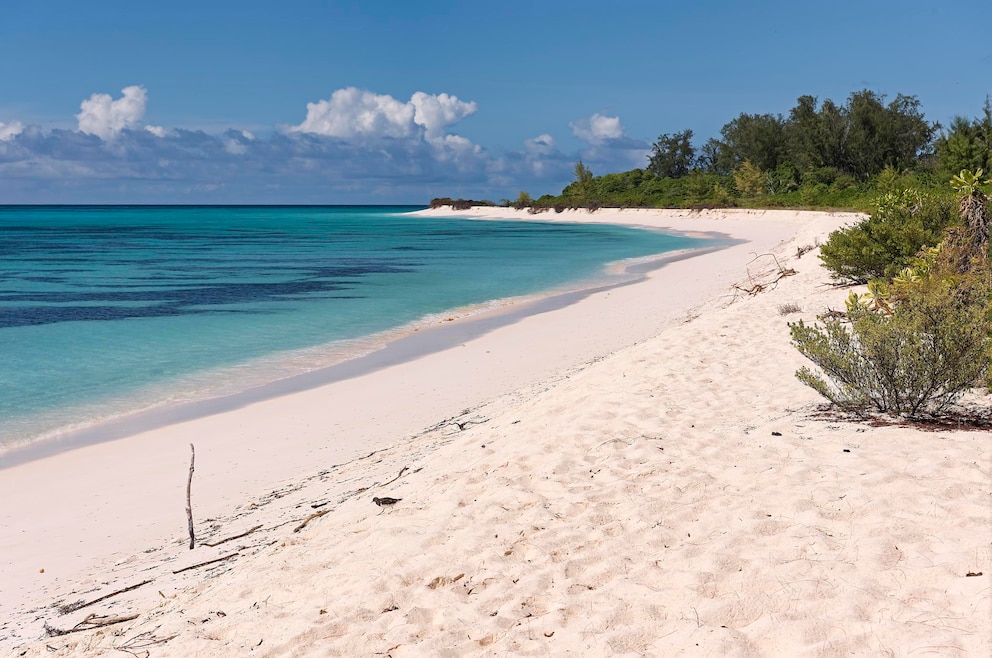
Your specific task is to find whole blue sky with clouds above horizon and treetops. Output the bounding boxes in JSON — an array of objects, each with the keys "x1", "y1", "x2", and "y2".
[{"x1": 0, "y1": 0, "x2": 992, "y2": 204}]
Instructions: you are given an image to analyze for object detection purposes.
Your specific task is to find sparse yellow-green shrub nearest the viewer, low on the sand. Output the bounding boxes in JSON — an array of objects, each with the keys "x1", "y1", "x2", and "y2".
[{"x1": 789, "y1": 273, "x2": 992, "y2": 417}]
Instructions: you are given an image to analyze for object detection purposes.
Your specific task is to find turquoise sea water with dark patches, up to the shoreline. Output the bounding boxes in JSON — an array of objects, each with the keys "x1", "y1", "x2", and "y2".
[{"x1": 0, "y1": 206, "x2": 702, "y2": 445}]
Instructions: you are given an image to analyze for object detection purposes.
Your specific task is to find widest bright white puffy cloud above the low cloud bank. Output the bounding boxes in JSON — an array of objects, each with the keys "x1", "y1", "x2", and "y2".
[{"x1": 290, "y1": 87, "x2": 478, "y2": 143}]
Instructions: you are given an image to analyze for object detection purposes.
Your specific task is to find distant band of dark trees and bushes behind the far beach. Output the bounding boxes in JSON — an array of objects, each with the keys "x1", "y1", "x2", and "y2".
[{"x1": 428, "y1": 90, "x2": 992, "y2": 211}]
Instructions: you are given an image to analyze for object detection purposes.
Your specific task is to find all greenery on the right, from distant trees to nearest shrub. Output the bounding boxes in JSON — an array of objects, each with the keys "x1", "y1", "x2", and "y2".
[{"x1": 431, "y1": 90, "x2": 992, "y2": 423}]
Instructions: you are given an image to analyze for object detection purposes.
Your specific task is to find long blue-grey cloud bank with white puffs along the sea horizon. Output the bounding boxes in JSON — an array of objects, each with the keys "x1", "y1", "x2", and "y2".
[{"x1": 0, "y1": 86, "x2": 649, "y2": 203}]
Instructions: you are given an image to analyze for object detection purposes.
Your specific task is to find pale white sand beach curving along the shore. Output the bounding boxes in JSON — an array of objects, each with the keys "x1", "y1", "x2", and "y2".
[{"x1": 0, "y1": 208, "x2": 992, "y2": 658}]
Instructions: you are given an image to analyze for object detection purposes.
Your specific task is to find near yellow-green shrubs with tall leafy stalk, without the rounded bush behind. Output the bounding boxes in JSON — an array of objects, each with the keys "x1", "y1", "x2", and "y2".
[{"x1": 789, "y1": 170, "x2": 992, "y2": 416}]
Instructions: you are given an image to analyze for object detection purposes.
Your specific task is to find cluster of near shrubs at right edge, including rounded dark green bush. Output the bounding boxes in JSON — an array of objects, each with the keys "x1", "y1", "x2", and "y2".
[{"x1": 790, "y1": 170, "x2": 992, "y2": 417}]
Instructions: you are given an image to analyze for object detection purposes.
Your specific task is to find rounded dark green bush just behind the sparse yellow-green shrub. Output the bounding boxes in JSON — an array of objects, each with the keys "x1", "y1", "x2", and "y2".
[{"x1": 820, "y1": 190, "x2": 958, "y2": 283}]
